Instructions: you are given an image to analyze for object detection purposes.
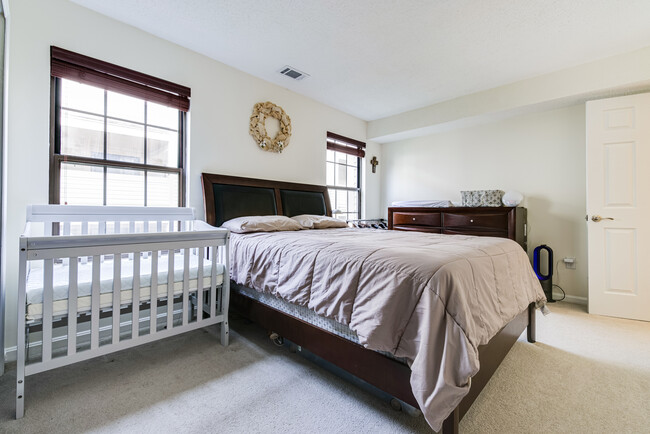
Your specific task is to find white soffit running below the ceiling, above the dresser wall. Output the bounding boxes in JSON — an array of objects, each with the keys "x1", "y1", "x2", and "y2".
[{"x1": 368, "y1": 47, "x2": 650, "y2": 143}]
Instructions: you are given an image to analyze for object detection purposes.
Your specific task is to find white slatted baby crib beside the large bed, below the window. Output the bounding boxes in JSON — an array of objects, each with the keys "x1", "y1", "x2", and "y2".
[{"x1": 16, "y1": 205, "x2": 230, "y2": 419}]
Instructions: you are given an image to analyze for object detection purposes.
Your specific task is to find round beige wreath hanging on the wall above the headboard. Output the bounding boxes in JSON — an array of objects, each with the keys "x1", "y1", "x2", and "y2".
[{"x1": 249, "y1": 101, "x2": 291, "y2": 152}]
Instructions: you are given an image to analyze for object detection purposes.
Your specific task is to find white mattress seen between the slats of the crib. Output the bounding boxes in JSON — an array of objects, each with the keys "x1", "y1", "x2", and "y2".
[{"x1": 27, "y1": 253, "x2": 224, "y2": 321}]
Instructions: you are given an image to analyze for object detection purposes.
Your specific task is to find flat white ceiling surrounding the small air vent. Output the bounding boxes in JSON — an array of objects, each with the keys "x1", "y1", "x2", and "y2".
[{"x1": 72, "y1": 0, "x2": 650, "y2": 120}]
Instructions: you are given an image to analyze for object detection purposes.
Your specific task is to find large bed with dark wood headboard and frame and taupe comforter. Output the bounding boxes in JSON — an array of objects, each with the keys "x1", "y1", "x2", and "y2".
[{"x1": 202, "y1": 174, "x2": 545, "y2": 433}]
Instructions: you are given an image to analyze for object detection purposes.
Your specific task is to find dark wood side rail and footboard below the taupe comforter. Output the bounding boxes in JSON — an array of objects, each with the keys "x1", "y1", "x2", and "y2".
[{"x1": 230, "y1": 283, "x2": 535, "y2": 434}]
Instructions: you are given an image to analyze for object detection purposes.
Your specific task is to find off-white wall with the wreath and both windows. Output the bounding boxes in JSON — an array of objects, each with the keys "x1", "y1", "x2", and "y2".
[{"x1": 4, "y1": 0, "x2": 380, "y2": 347}]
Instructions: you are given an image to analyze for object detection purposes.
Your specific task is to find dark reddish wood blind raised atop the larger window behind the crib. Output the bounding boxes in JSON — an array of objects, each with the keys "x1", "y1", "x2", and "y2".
[{"x1": 50, "y1": 47, "x2": 191, "y2": 112}]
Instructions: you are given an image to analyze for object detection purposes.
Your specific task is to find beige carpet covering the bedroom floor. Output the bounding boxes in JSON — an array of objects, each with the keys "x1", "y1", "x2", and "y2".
[{"x1": 0, "y1": 303, "x2": 650, "y2": 433}]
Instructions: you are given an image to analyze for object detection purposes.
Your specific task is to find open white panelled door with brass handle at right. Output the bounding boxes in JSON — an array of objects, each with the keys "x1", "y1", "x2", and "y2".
[{"x1": 587, "y1": 94, "x2": 650, "y2": 321}]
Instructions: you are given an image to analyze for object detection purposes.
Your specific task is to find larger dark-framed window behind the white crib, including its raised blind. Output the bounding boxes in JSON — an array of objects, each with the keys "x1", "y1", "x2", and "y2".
[{"x1": 50, "y1": 47, "x2": 190, "y2": 206}]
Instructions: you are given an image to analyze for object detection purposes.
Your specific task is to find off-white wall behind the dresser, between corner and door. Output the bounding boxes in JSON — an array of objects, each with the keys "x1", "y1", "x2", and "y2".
[{"x1": 381, "y1": 104, "x2": 587, "y2": 297}]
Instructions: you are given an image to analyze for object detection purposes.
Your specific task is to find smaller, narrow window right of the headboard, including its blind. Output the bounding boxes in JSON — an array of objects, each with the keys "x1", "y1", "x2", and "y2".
[{"x1": 326, "y1": 132, "x2": 366, "y2": 220}]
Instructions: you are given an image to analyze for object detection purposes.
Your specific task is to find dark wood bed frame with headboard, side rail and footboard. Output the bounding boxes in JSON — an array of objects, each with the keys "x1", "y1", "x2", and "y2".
[{"x1": 202, "y1": 173, "x2": 535, "y2": 434}]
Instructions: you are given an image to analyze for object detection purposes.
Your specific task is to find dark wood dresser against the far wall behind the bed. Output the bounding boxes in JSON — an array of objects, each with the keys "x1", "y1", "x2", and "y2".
[{"x1": 388, "y1": 207, "x2": 528, "y2": 251}]
